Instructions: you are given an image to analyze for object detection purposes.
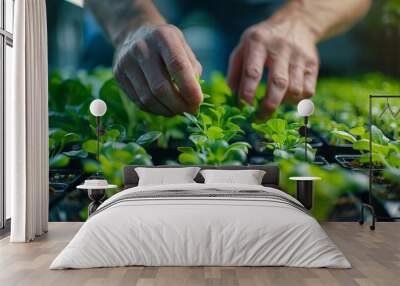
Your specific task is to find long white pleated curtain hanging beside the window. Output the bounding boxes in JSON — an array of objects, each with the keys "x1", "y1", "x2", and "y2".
[{"x1": 6, "y1": 0, "x2": 49, "y2": 242}]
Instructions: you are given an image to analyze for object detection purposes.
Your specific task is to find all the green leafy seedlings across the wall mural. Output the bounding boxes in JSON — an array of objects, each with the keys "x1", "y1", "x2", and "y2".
[{"x1": 49, "y1": 69, "x2": 400, "y2": 219}]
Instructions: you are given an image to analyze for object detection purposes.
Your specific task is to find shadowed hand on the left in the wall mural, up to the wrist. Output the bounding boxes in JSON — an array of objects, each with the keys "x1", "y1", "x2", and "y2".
[{"x1": 113, "y1": 24, "x2": 203, "y2": 116}]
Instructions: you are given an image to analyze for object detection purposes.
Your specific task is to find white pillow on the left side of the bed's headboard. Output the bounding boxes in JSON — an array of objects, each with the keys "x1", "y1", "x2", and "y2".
[{"x1": 135, "y1": 167, "x2": 200, "y2": 186}]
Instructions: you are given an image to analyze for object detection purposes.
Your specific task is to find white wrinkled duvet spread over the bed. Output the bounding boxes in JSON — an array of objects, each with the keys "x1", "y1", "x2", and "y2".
[{"x1": 50, "y1": 184, "x2": 351, "y2": 269}]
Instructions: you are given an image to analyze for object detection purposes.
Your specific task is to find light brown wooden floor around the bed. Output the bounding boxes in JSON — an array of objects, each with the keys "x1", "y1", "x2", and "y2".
[{"x1": 0, "y1": 222, "x2": 400, "y2": 286}]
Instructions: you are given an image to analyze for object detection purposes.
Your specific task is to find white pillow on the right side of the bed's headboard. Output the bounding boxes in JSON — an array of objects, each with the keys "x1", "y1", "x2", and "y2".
[{"x1": 200, "y1": 169, "x2": 265, "y2": 185}]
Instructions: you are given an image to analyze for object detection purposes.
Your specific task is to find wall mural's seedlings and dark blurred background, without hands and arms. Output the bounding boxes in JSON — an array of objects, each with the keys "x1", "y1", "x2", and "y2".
[{"x1": 47, "y1": 1, "x2": 400, "y2": 221}]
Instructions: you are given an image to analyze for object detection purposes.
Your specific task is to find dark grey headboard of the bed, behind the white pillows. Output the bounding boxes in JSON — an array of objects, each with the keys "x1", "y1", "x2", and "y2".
[{"x1": 124, "y1": 164, "x2": 281, "y2": 189}]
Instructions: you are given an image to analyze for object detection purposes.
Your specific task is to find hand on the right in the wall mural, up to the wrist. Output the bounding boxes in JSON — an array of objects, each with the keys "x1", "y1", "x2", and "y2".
[{"x1": 228, "y1": 17, "x2": 319, "y2": 118}]
